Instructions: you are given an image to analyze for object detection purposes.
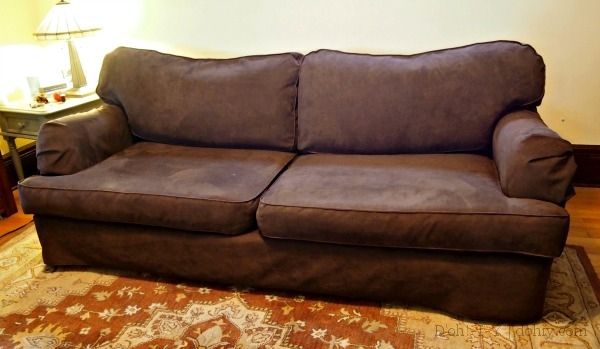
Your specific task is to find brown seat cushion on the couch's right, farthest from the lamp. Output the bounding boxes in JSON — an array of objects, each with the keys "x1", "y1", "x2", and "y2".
[{"x1": 257, "y1": 154, "x2": 569, "y2": 257}]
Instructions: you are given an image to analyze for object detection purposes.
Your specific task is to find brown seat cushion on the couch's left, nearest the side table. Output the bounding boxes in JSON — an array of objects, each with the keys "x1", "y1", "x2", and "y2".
[{"x1": 19, "y1": 142, "x2": 294, "y2": 234}]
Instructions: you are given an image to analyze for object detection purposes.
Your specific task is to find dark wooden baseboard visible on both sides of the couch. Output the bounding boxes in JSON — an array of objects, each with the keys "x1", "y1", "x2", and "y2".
[{"x1": 2, "y1": 143, "x2": 600, "y2": 188}]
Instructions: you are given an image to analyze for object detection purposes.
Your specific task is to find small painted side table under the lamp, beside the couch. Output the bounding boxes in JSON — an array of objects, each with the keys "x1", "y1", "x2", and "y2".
[{"x1": 0, "y1": 94, "x2": 102, "y2": 180}]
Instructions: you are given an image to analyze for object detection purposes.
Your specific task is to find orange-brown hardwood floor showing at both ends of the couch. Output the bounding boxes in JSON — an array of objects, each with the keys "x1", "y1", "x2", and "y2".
[{"x1": 0, "y1": 187, "x2": 600, "y2": 273}]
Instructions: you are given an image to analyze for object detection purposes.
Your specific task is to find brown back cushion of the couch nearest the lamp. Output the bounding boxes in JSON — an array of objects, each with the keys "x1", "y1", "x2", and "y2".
[{"x1": 97, "y1": 48, "x2": 301, "y2": 150}]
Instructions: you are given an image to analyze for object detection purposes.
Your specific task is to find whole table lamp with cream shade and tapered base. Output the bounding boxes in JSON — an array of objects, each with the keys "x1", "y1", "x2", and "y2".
[{"x1": 33, "y1": 0, "x2": 100, "y2": 97}]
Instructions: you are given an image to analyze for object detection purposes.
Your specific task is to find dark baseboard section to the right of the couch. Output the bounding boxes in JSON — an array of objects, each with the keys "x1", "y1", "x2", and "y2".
[{"x1": 573, "y1": 144, "x2": 600, "y2": 187}]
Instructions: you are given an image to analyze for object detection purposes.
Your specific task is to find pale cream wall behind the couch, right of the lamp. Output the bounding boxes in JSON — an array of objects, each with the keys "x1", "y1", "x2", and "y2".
[{"x1": 0, "y1": 0, "x2": 600, "y2": 144}]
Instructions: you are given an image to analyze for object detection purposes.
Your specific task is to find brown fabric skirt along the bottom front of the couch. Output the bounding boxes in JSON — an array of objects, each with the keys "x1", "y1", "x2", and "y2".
[{"x1": 35, "y1": 215, "x2": 552, "y2": 323}]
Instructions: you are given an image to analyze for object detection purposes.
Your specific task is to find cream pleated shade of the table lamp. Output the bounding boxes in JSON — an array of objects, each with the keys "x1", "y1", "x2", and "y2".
[{"x1": 33, "y1": 0, "x2": 100, "y2": 40}]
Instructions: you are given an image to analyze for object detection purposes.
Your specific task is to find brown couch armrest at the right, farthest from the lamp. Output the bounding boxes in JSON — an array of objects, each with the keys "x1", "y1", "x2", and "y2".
[{"x1": 493, "y1": 110, "x2": 577, "y2": 205}]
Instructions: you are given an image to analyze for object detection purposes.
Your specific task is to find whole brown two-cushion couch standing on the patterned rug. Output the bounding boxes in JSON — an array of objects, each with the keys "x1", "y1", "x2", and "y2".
[{"x1": 19, "y1": 41, "x2": 575, "y2": 322}]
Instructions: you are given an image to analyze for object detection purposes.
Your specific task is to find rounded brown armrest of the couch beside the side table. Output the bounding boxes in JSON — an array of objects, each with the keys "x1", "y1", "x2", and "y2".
[{"x1": 36, "y1": 104, "x2": 132, "y2": 175}]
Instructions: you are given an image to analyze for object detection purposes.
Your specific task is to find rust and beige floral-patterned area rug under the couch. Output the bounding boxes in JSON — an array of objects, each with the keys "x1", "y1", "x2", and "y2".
[{"x1": 0, "y1": 226, "x2": 600, "y2": 349}]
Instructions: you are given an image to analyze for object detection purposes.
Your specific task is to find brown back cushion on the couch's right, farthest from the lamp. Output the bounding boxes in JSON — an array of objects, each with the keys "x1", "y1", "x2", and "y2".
[{"x1": 298, "y1": 41, "x2": 545, "y2": 154}]
